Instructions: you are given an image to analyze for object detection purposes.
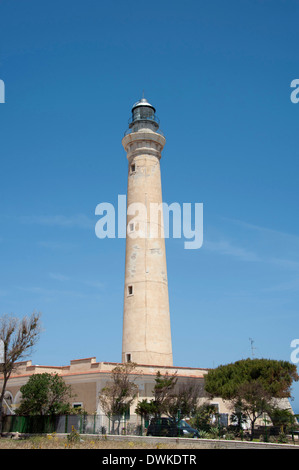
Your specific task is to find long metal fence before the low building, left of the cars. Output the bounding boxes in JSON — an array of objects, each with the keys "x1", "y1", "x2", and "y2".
[{"x1": 3, "y1": 415, "x2": 146, "y2": 436}]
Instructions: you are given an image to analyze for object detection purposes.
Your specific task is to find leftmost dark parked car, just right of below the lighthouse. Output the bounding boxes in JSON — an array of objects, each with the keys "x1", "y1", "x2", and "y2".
[{"x1": 146, "y1": 418, "x2": 199, "y2": 437}]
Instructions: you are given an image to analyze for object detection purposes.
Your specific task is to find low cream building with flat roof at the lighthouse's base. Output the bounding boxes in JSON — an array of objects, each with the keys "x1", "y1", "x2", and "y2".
[{"x1": 0, "y1": 357, "x2": 292, "y2": 422}]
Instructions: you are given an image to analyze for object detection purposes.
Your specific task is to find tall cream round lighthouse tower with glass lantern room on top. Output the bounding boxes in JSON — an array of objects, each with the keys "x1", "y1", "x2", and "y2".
[{"x1": 122, "y1": 98, "x2": 173, "y2": 366}]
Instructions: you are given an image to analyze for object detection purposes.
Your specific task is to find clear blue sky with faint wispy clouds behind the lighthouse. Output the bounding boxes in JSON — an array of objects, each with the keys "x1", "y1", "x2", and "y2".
[{"x1": 0, "y1": 0, "x2": 299, "y2": 411}]
